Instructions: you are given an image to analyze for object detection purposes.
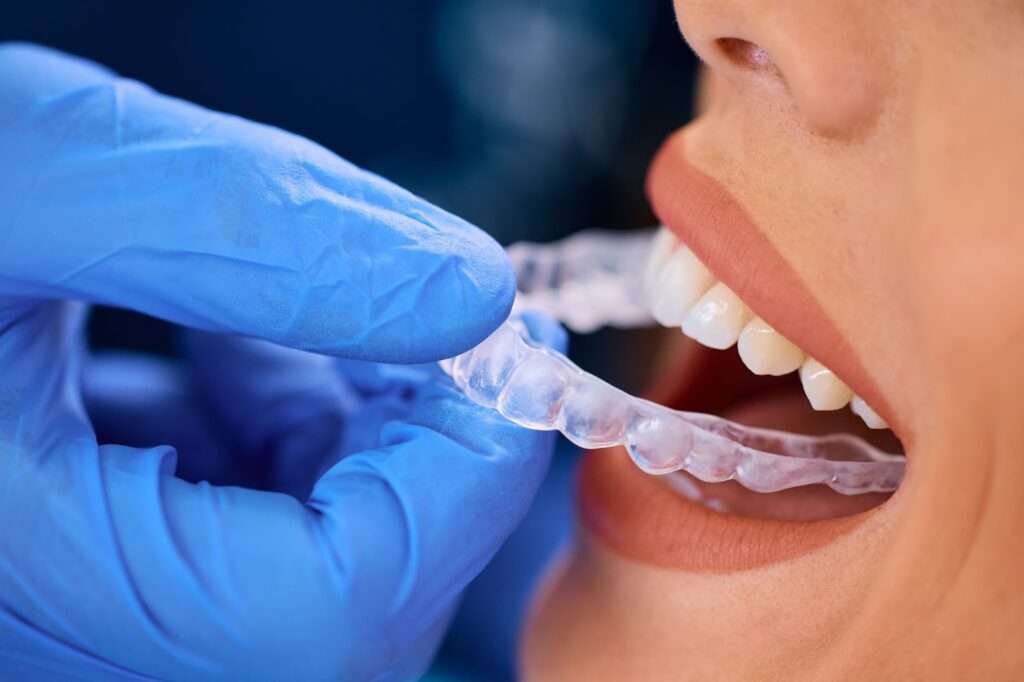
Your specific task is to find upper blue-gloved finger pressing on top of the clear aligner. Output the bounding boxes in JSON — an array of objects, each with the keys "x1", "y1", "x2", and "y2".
[{"x1": 0, "y1": 45, "x2": 515, "y2": 363}]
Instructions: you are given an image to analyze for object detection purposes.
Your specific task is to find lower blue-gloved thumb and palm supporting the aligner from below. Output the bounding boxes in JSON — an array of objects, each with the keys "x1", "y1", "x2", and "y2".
[{"x1": 0, "y1": 315, "x2": 565, "y2": 680}]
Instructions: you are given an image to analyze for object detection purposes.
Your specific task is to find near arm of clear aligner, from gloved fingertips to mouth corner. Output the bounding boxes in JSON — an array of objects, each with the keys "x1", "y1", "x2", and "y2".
[{"x1": 441, "y1": 322, "x2": 904, "y2": 495}]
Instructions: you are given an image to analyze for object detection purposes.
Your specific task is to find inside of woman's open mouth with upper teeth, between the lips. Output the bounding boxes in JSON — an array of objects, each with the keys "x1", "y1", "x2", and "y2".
[{"x1": 644, "y1": 222, "x2": 903, "y2": 520}]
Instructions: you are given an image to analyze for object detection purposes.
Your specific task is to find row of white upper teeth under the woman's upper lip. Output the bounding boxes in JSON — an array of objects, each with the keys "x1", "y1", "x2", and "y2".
[{"x1": 644, "y1": 227, "x2": 887, "y2": 429}]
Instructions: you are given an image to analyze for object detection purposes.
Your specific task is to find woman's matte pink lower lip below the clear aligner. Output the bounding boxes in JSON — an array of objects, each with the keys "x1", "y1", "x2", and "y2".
[{"x1": 578, "y1": 447, "x2": 878, "y2": 572}]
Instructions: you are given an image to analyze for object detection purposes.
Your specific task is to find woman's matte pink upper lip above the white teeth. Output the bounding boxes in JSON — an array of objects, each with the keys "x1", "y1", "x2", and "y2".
[{"x1": 647, "y1": 130, "x2": 899, "y2": 440}]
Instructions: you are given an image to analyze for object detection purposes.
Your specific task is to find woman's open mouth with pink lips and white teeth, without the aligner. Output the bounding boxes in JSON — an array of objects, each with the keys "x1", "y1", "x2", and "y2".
[{"x1": 580, "y1": 131, "x2": 903, "y2": 570}]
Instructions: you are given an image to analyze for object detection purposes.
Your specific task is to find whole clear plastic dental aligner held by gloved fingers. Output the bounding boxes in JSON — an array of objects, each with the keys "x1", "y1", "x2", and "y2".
[{"x1": 441, "y1": 228, "x2": 905, "y2": 495}]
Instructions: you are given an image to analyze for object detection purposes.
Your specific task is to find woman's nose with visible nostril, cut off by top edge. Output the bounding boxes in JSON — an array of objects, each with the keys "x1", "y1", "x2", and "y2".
[{"x1": 676, "y1": 0, "x2": 895, "y2": 139}]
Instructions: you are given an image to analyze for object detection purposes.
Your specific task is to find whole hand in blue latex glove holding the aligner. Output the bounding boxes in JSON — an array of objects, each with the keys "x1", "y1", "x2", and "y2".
[{"x1": 0, "y1": 45, "x2": 565, "y2": 680}]
